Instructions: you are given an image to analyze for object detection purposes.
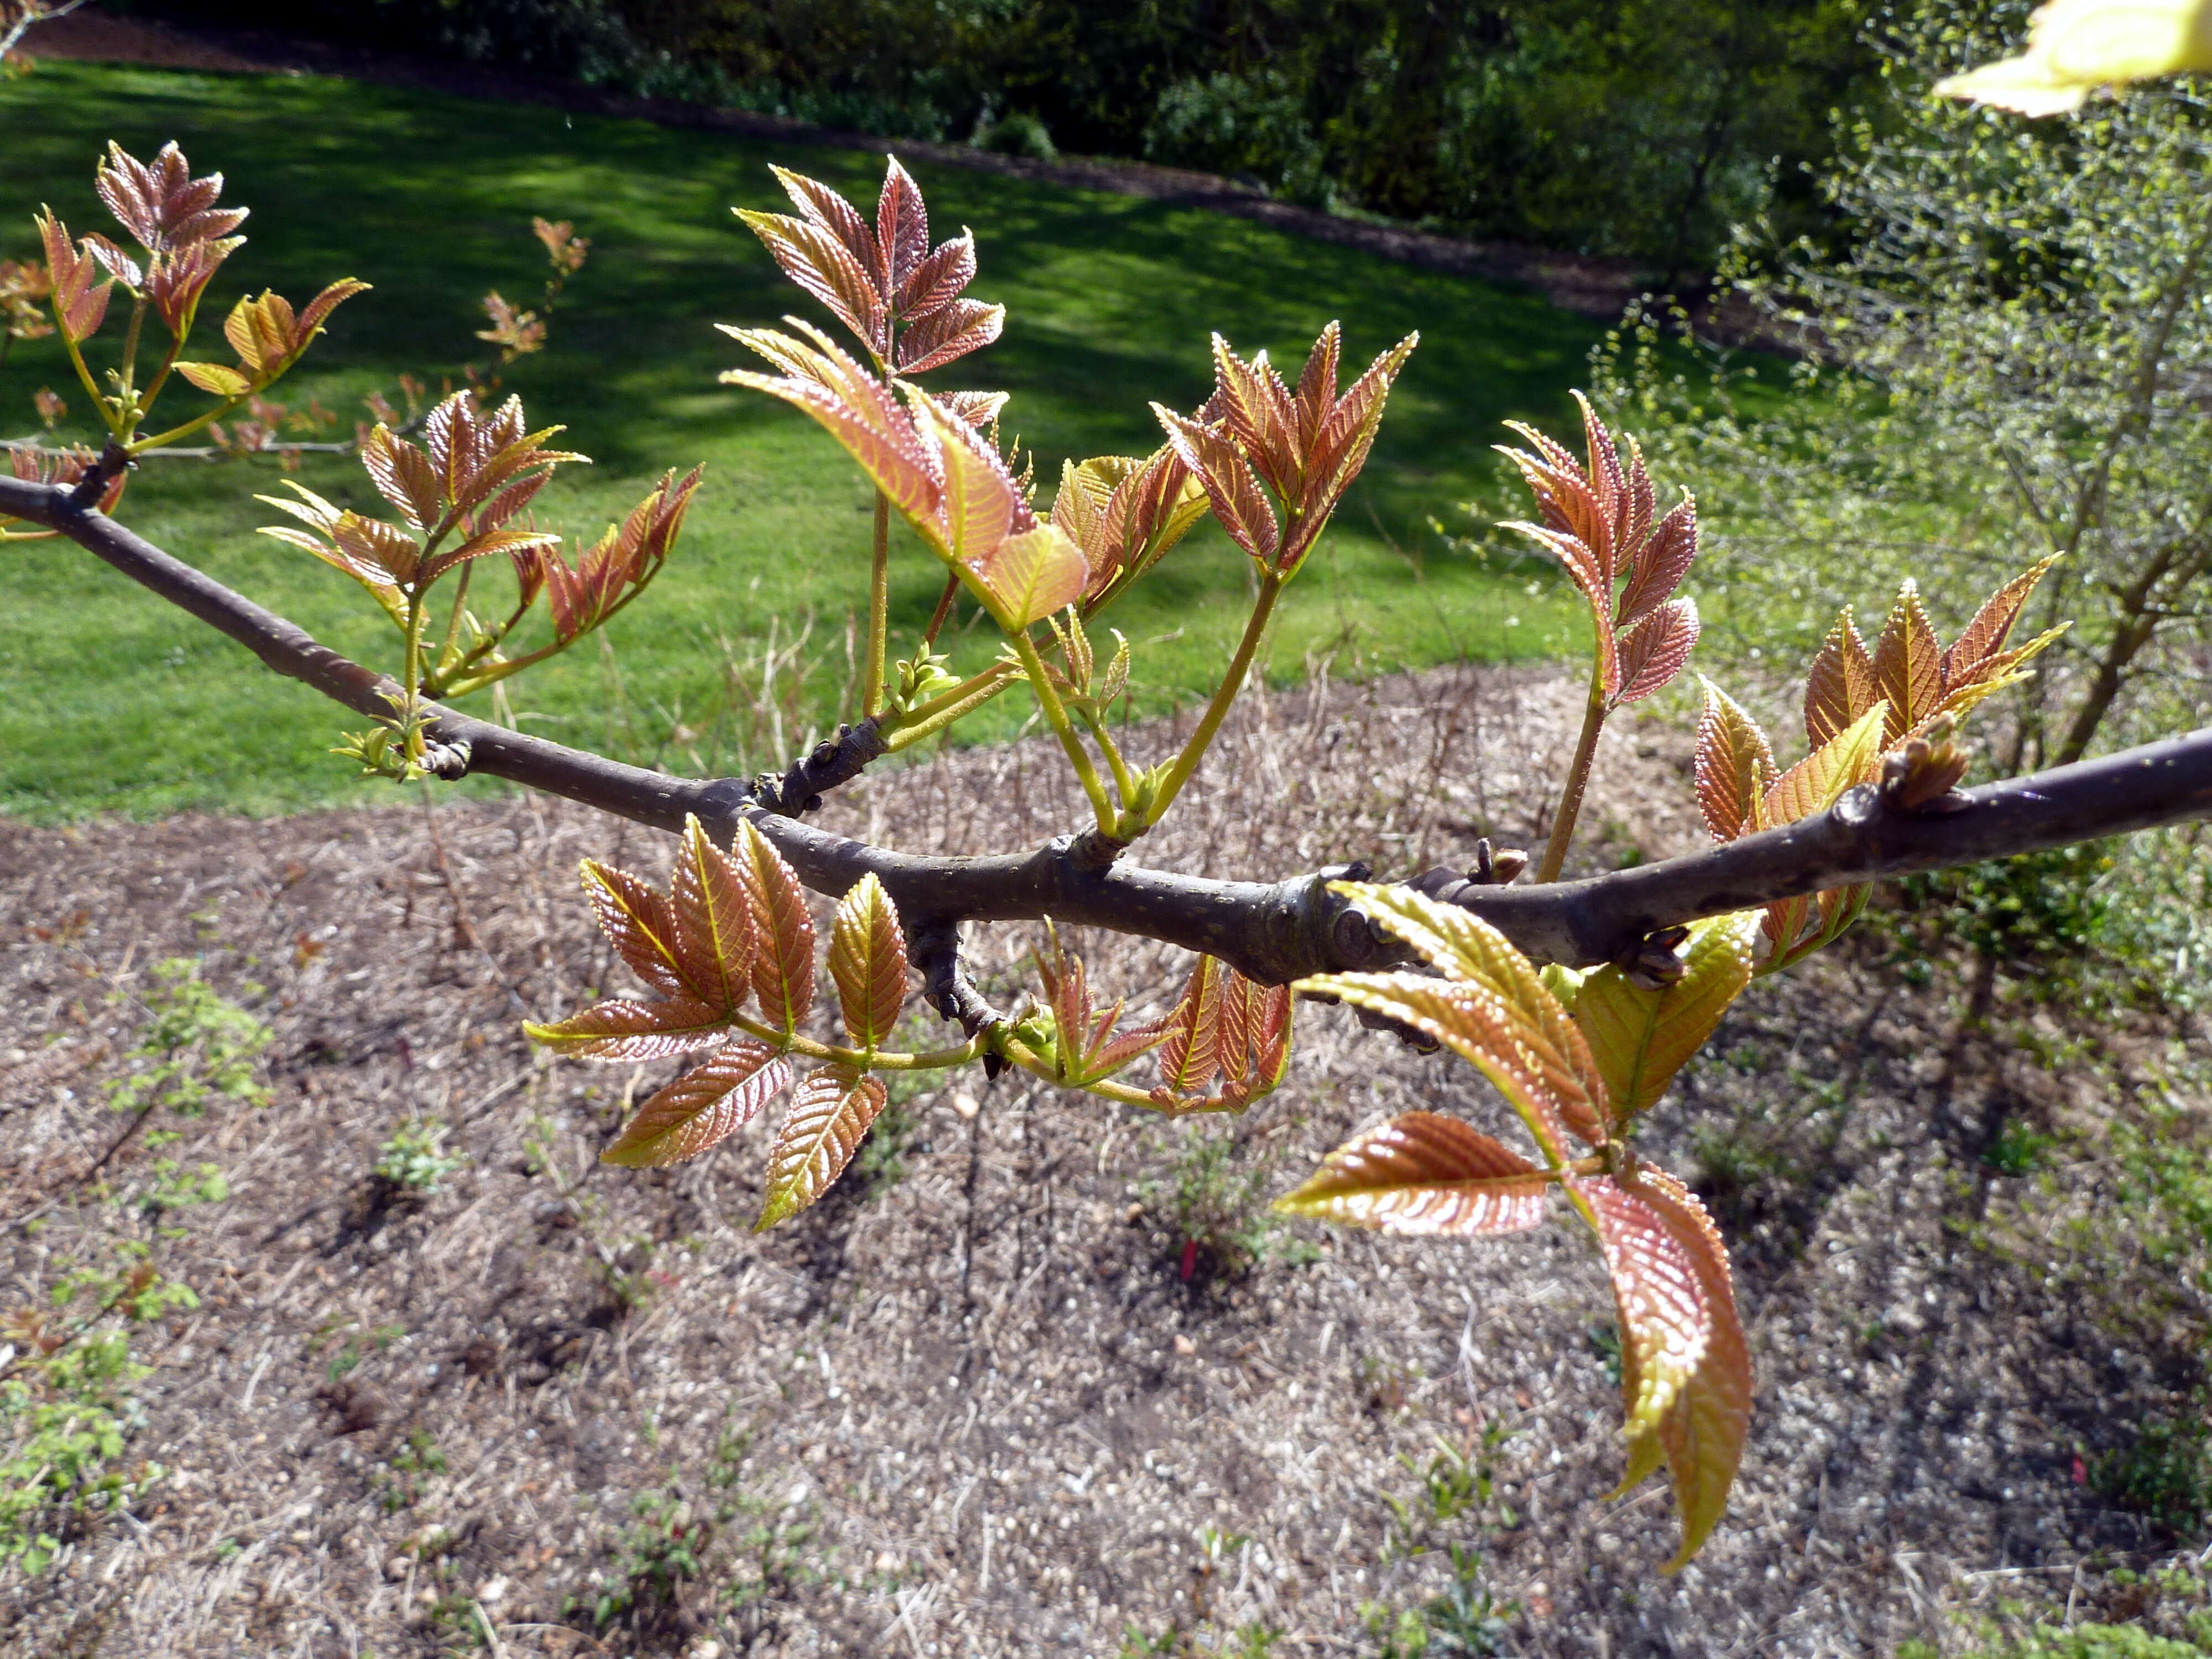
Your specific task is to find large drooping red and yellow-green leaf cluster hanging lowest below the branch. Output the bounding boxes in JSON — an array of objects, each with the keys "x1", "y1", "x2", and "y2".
[{"x1": 1279, "y1": 883, "x2": 1756, "y2": 1571}]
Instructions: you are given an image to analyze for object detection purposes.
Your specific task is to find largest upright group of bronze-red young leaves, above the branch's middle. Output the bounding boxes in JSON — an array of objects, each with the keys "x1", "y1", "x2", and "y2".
[{"x1": 721, "y1": 159, "x2": 1416, "y2": 845}]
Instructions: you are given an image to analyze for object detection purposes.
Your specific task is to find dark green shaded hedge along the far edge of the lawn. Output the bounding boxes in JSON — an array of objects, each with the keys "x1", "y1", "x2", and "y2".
[{"x1": 153, "y1": 0, "x2": 1874, "y2": 276}]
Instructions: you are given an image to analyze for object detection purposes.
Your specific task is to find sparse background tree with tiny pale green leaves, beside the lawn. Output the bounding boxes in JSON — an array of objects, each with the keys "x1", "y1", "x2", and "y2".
[{"x1": 1613, "y1": 4, "x2": 2212, "y2": 779}]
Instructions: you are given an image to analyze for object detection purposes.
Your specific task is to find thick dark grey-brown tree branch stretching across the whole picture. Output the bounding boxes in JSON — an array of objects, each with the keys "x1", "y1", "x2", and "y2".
[{"x1": 13, "y1": 478, "x2": 2212, "y2": 995}]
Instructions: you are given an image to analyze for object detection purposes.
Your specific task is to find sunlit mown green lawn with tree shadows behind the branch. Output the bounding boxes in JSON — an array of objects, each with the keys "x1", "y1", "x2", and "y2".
[{"x1": 0, "y1": 62, "x2": 1597, "y2": 818}]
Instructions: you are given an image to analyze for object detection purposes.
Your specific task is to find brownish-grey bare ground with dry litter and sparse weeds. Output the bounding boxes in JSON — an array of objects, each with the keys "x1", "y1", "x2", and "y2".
[{"x1": 0, "y1": 670, "x2": 2208, "y2": 1657}]
